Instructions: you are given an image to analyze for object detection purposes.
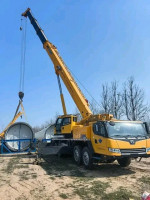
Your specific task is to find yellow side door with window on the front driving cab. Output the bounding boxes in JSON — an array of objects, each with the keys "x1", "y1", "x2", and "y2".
[{"x1": 91, "y1": 122, "x2": 107, "y2": 154}]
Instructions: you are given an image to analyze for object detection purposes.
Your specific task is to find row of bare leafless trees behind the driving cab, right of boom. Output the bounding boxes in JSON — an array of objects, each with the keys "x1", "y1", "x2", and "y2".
[{"x1": 90, "y1": 77, "x2": 149, "y2": 121}]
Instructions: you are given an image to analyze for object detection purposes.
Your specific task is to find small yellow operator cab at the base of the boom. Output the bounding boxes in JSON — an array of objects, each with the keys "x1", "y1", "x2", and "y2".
[{"x1": 54, "y1": 115, "x2": 77, "y2": 138}]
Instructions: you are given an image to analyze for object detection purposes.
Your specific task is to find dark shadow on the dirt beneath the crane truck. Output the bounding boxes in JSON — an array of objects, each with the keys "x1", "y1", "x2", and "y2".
[{"x1": 39, "y1": 156, "x2": 135, "y2": 178}]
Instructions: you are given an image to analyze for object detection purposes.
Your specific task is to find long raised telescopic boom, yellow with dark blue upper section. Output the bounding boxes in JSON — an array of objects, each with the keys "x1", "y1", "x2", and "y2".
[{"x1": 22, "y1": 8, "x2": 92, "y2": 119}]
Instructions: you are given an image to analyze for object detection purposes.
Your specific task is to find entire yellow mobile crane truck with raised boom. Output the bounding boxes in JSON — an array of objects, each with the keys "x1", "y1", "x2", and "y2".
[{"x1": 22, "y1": 8, "x2": 150, "y2": 169}]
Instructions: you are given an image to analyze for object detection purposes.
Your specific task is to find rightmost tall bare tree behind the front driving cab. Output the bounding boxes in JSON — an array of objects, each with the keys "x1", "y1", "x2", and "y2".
[{"x1": 123, "y1": 77, "x2": 149, "y2": 121}]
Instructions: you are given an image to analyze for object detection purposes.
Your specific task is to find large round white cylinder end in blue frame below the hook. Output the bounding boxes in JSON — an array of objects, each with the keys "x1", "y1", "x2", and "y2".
[{"x1": 5, "y1": 122, "x2": 34, "y2": 151}]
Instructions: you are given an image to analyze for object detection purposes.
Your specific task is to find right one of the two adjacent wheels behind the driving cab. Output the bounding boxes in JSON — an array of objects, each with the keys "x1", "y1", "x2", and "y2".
[{"x1": 82, "y1": 147, "x2": 93, "y2": 169}]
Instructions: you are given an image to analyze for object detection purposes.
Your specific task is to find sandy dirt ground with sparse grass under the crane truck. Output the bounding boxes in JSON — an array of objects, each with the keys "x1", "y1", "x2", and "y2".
[{"x1": 0, "y1": 155, "x2": 150, "y2": 200}]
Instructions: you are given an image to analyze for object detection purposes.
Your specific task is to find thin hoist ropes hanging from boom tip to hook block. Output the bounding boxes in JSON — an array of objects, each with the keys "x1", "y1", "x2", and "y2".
[{"x1": 19, "y1": 19, "x2": 27, "y2": 92}]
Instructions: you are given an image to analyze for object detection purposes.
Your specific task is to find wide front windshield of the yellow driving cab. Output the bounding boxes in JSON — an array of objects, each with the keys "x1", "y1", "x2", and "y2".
[{"x1": 107, "y1": 122, "x2": 147, "y2": 137}]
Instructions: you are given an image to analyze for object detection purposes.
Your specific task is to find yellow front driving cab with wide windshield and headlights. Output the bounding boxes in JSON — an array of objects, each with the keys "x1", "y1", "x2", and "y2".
[{"x1": 91, "y1": 121, "x2": 150, "y2": 157}]
